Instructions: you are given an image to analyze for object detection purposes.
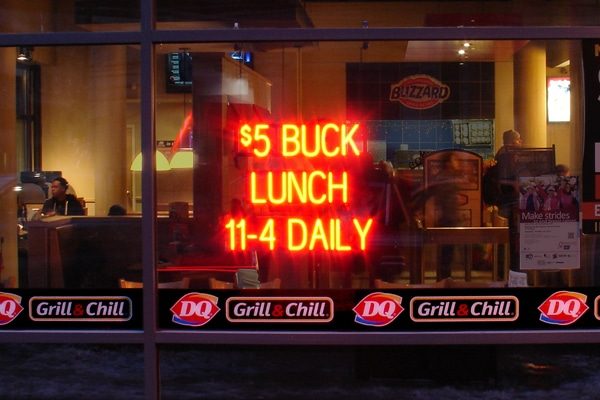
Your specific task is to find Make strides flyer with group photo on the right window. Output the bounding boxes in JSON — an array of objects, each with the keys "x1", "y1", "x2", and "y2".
[{"x1": 519, "y1": 175, "x2": 580, "y2": 270}]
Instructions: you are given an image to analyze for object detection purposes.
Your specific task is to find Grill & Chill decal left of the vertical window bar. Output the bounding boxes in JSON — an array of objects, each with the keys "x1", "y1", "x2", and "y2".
[{"x1": 29, "y1": 296, "x2": 132, "y2": 322}]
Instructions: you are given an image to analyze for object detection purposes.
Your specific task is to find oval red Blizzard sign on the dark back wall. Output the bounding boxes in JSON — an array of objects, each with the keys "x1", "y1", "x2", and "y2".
[{"x1": 390, "y1": 74, "x2": 450, "y2": 110}]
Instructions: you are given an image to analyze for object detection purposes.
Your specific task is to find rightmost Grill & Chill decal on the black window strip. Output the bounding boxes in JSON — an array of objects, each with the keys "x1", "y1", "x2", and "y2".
[{"x1": 410, "y1": 296, "x2": 519, "y2": 322}]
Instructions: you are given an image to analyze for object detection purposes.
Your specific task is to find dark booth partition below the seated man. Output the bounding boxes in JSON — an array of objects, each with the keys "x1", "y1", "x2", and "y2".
[{"x1": 27, "y1": 216, "x2": 182, "y2": 288}]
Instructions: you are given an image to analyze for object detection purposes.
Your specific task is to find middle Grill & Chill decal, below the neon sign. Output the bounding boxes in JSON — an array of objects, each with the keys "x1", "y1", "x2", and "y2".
[{"x1": 226, "y1": 297, "x2": 333, "y2": 323}]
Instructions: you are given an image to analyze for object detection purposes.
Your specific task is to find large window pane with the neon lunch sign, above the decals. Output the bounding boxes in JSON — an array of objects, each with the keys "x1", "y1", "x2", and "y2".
[{"x1": 155, "y1": 40, "x2": 594, "y2": 289}]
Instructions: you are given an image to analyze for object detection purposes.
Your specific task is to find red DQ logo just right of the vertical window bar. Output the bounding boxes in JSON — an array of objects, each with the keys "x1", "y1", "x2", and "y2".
[{"x1": 171, "y1": 293, "x2": 221, "y2": 326}]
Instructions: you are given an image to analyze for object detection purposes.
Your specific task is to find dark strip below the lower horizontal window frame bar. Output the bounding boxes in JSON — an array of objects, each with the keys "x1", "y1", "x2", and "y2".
[{"x1": 0, "y1": 344, "x2": 600, "y2": 400}]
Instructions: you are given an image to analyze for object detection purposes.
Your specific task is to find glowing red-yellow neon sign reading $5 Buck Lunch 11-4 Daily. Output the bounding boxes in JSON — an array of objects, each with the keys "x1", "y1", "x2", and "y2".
[{"x1": 224, "y1": 123, "x2": 373, "y2": 252}]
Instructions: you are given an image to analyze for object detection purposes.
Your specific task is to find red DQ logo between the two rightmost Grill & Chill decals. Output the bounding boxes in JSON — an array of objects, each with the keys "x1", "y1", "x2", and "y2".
[{"x1": 352, "y1": 292, "x2": 404, "y2": 327}]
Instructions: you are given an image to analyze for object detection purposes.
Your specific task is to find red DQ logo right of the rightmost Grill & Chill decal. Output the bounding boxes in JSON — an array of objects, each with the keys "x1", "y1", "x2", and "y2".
[{"x1": 538, "y1": 291, "x2": 589, "y2": 325}]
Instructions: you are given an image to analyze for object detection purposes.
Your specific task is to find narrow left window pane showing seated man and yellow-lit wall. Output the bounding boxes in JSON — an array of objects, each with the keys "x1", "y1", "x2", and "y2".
[{"x1": 6, "y1": 45, "x2": 142, "y2": 290}]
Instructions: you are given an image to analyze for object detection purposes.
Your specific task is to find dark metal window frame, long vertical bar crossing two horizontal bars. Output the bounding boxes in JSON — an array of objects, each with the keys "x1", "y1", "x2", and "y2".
[{"x1": 0, "y1": 0, "x2": 600, "y2": 399}]
